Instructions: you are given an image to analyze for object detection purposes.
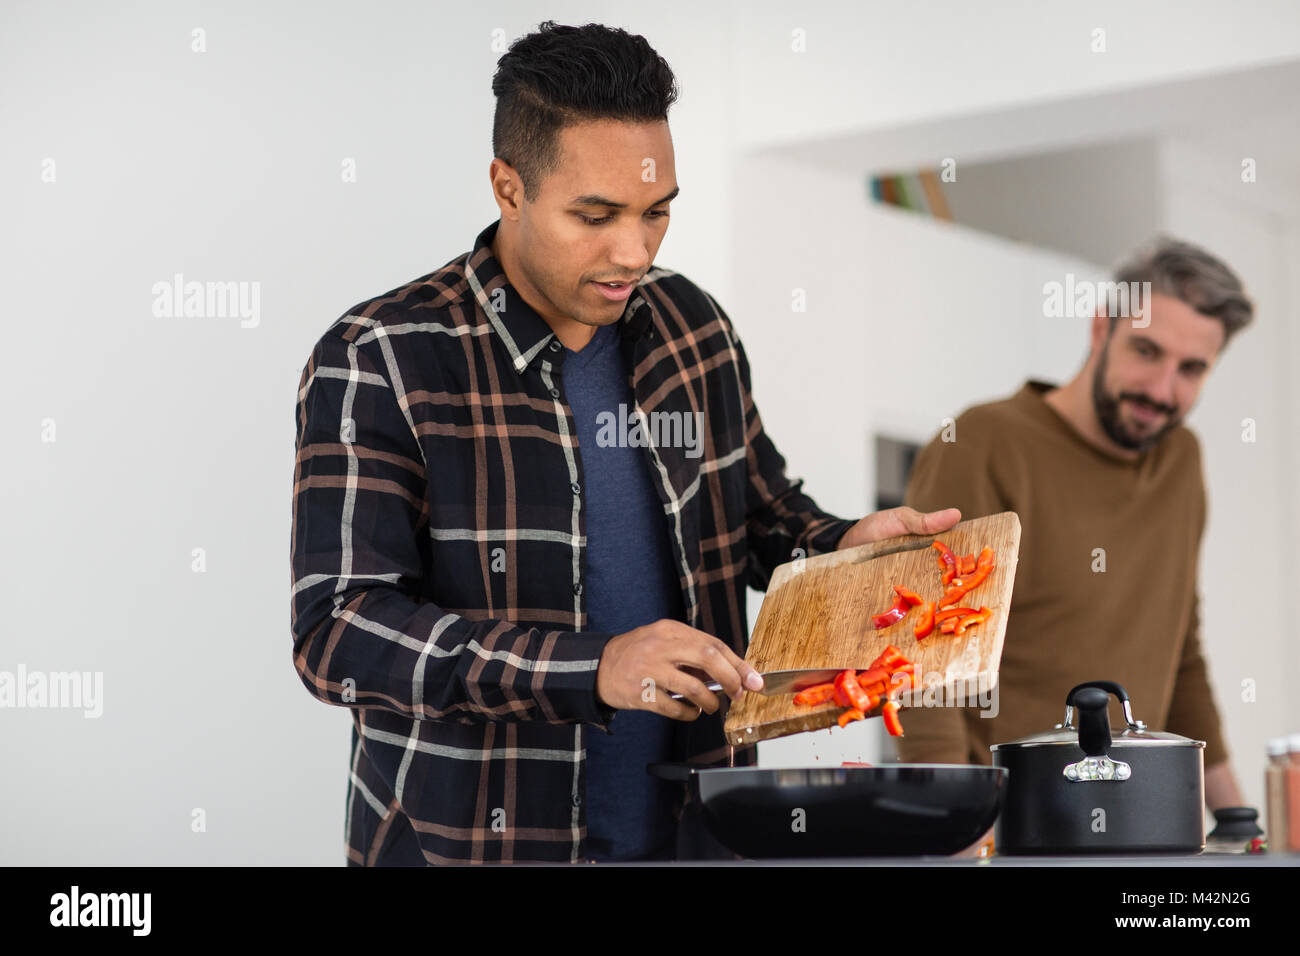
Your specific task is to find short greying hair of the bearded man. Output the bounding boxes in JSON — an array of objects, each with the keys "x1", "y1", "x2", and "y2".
[{"x1": 1110, "y1": 235, "x2": 1255, "y2": 346}]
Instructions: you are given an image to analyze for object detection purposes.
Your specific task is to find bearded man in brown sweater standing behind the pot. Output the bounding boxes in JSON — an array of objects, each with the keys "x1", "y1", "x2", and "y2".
[{"x1": 898, "y1": 238, "x2": 1253, "y2": 809}]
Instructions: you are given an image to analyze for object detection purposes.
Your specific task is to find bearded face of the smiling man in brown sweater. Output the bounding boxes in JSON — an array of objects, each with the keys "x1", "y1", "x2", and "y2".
[{"x1": 1092, "y1": 294, "x2": 1223, "y2": 451}]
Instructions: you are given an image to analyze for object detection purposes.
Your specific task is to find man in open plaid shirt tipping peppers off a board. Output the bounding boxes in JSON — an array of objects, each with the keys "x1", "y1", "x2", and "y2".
[{"x1": 291, "y1": 22, "x2": 958, "y2": 865}]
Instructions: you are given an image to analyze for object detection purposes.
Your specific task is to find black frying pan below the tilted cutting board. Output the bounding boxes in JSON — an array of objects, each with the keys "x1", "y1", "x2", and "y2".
[{"x1": 646, "y1": 763, "x2": 1008, "y2": 858}]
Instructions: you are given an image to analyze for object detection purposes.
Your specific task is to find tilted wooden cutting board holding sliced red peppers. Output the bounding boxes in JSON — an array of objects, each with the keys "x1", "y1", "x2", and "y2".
[{"x1": 725, "y1": 511, "x2": 1021, "y2": 747}]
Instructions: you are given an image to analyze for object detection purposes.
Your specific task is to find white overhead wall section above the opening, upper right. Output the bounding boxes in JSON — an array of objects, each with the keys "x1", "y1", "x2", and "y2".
[{"x1": 733, "y1": 0, "x2": 1300, "y2": 148}]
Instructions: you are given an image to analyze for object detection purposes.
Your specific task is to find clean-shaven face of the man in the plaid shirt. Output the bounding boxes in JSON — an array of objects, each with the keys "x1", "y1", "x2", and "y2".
[{"x1": 506, "y1": 120, "x2": 677, "y2": 325}]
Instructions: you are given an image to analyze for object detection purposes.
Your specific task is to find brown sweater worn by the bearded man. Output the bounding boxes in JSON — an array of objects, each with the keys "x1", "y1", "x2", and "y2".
[{"x1": 898, "y1": 381, "x2": 1227, "y2": 767}]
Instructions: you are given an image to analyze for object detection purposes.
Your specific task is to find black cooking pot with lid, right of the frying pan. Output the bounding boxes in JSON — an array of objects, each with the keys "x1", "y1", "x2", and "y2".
[{"x1": 991, "y1": 680, "x2": 1205, "y2": 855}]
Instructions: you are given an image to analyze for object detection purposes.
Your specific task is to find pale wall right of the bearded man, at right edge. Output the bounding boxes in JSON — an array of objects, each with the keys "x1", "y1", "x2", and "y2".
[{"x1": 1161, "y1": 140, "x2": 1300, "y2": 806}]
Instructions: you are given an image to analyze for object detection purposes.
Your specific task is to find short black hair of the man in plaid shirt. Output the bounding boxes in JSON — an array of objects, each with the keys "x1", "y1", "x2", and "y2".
[{"x1": 491, "y1": 20, "x2": 677, "y2": 200}]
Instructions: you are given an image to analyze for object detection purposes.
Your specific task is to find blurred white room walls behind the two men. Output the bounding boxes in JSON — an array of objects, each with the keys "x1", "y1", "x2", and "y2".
[{"x1": 0, "y1": 0, "x2": 1300, "y2": 865}]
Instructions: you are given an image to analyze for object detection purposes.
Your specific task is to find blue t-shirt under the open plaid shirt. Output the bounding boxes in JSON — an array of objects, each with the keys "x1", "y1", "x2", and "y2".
[{"x1": 560, "y1": 324, "x2": 685, "y2": 861}]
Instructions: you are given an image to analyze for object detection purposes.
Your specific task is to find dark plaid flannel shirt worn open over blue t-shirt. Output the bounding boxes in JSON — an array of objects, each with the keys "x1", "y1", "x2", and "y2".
[{"x1": 291, "y1": 221, "x2": 853, "y2": 865}]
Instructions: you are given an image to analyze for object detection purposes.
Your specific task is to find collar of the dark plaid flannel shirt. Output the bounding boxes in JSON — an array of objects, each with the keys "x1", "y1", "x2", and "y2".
[{"x1": 465, "y1": 219, "x2": 651, "y2": 372}]
